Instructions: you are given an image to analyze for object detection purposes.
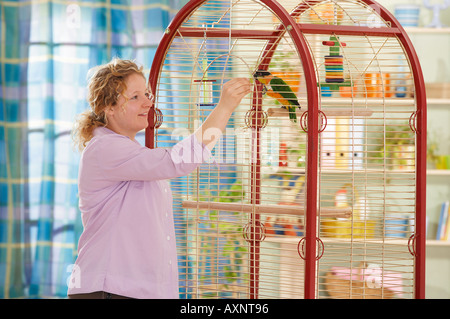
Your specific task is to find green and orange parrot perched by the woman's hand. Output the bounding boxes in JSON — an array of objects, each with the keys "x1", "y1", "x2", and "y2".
[{"x1": 253, "y1": 70, "x2": 301, "y2": 123}]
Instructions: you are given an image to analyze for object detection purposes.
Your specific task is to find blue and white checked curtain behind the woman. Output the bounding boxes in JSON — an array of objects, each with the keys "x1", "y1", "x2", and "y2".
[{"x1": 0, "y1": 0, "x2": 186, "y2": 298}]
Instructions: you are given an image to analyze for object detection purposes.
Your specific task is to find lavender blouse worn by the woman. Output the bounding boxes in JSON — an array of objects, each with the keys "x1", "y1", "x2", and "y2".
[{"x1": 68, "y1": 127, "x2": 211, "y2": 298}]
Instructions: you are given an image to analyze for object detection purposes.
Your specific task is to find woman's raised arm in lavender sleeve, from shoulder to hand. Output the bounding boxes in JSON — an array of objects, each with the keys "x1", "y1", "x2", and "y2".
[{"x1": 83, "y1": 79, "x2": 251, "y2": 181}]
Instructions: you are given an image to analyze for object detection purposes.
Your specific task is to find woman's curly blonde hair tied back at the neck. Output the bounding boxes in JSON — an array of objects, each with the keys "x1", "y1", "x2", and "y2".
[{"x1": 72, "y1": 58, "x2": 145, "y2": 151}]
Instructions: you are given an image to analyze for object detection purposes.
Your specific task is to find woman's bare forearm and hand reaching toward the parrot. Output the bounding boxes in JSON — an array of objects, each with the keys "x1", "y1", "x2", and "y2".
[{"x1": 194, "y1": 78, "x2": 251, "y2": 150}]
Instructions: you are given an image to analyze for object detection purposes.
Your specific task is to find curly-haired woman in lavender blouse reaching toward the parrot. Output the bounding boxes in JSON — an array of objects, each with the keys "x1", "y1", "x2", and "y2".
[{"x1": 68, "y1": 59, "x2": 251, "y2": 298}]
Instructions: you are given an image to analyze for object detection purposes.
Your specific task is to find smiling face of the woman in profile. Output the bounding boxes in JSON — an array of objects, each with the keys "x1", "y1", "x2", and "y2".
[{"x1": 107, "y1": 73, "x2": 153, "y2": 139}]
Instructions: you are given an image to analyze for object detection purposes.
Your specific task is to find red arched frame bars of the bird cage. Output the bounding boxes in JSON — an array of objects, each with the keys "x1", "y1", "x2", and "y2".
[{"x1": 145, "y1": 0, "x2": 427, "y2": 299}]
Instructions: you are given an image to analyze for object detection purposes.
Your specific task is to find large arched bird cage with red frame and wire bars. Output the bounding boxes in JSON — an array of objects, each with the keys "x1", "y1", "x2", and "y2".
[{"x1": 146, "y1": 0, "x2": 426, "y2": 298}]
